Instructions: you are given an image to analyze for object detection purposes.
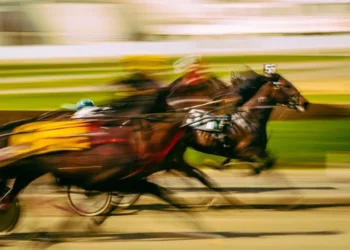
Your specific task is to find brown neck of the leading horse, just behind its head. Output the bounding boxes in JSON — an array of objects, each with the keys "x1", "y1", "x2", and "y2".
[{"x1": 242, "y1": 84, "x2": 276, "y2": 128}]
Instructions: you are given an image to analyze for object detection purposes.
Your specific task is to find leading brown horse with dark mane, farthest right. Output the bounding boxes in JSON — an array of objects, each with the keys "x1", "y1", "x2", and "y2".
[{"x1": 180, "y1": 71, "x2": 309, "y2": 174}]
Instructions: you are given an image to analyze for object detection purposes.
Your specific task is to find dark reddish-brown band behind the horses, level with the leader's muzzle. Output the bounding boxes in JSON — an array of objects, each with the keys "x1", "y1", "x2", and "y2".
[{"x1": 0, "y1": 104, "x2": 350, "y2": 124}]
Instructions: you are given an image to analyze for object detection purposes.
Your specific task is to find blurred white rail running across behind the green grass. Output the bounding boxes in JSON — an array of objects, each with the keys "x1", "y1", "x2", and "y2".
[{"x1": 0, "y1": 35, "x2": 350, "y2": 63}]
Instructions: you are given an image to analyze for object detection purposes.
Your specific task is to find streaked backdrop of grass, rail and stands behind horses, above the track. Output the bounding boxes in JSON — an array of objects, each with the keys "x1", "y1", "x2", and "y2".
[{"x1": 0, "y1": 0, "x2": 350, "y2": 177}]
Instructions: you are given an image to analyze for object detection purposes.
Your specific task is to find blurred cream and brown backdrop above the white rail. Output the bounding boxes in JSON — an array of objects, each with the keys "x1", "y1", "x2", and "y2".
[{"x1": 0, "y1": 0, "x2": 350, "y2": 44}]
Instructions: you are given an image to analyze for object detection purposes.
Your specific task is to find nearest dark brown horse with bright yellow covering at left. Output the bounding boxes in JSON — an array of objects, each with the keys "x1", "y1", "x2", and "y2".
[{"x1": 0, "y1": 89, "x2": 241, "y2": 233}]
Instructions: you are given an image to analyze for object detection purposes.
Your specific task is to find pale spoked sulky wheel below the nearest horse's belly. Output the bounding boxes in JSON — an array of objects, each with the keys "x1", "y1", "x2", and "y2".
[{"x1": 67, "y1": 186, "x2": 112, "y2": 217}]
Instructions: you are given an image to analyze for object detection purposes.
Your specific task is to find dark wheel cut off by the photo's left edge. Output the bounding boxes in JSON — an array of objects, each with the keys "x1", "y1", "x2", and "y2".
[{"x1": 0, "y1": 189, "x2": 21, "y2": 235}]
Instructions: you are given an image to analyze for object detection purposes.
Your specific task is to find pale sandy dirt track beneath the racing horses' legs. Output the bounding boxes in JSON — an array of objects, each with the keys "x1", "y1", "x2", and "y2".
[{"x1": 0, "y1": 170, "x2": 350, "y2": 250}]
